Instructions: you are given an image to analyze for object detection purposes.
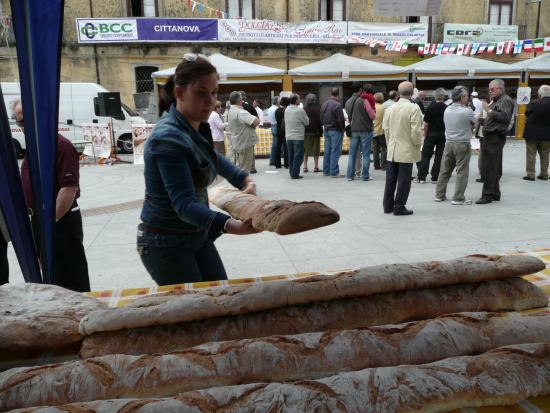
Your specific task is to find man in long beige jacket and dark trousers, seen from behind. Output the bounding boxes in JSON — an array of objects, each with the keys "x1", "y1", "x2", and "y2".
[{"x1": 382, "y1": 82, "x2": 422, "y2": 215}]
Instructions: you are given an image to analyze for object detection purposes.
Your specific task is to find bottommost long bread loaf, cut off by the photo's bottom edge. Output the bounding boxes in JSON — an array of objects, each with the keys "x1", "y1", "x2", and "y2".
[{"x1": 11, "y1": 343, "x2": 550, "y2": 413}]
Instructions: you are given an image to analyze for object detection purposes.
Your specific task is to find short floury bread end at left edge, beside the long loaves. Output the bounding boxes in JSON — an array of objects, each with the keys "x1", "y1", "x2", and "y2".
[{"x1": 0, "y1": 283, "x2": 105, "y2": 355}]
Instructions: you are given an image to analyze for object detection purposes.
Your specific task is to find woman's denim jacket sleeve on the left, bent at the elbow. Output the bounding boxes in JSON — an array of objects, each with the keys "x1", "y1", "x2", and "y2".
[{"x1": 157, "y1": 150, "x2": 230, "y2": 234}]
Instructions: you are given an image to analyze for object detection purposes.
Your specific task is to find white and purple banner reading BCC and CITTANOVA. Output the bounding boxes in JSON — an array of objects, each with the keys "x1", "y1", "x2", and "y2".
[{"x1": 76, "y1": 18, "x2": 218, "y2": 43}]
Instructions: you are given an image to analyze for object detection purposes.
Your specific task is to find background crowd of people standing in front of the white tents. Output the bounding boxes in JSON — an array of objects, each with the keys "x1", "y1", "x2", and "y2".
[{"x1": 211, "y1": 79, "x2": 550, "y2": 215}]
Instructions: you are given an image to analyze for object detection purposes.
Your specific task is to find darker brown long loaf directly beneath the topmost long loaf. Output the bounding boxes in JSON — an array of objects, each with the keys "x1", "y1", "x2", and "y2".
[{"x1": 80, "y1": 278, "x2": 548, "y2": 358}]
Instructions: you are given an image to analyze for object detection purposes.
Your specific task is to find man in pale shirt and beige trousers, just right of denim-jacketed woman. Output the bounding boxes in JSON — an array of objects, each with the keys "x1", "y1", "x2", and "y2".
[{"x1": 227, "y1": 92, "x2": 260, "y2": 172}]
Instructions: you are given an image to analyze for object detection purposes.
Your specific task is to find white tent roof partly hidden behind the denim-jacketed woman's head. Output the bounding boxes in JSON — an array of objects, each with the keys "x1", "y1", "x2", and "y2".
[{"x1": 151, "y1": 53, "x2": 285, "y2": 79}]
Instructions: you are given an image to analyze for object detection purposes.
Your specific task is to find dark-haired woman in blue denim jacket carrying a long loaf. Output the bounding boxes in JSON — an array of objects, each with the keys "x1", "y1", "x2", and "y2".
[{"x1": 137, "y1": 53, "x2": 259, "y2": 285}]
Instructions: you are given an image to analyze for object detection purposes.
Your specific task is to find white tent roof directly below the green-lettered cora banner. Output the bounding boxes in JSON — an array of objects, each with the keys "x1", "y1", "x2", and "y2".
[{"x1": 405, "y1": 54, "x2": 521, "y2": 80}]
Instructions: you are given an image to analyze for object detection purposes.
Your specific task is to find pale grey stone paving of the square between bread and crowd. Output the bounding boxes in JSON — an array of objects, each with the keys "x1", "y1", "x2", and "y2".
[{"x1": 5, "y1": 140, "x2": 550, "y2": 290}]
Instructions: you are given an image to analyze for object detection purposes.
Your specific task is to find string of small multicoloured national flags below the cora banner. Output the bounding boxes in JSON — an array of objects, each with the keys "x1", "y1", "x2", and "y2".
[{"x1": 382, "y1": 37, "x2": 550, "y2": 56}]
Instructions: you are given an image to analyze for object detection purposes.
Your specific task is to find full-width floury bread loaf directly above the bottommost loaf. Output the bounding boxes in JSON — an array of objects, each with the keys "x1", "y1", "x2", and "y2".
[{"x1": 0, "y1": 313, "x2": 550, "y2": 411}]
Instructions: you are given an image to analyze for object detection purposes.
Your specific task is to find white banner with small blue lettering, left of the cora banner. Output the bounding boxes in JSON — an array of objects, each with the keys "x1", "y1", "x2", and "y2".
[{"x1": 348, "y1": 22, "x2": 428, "y2": 44}]
